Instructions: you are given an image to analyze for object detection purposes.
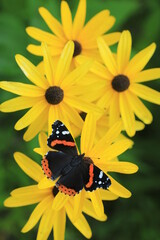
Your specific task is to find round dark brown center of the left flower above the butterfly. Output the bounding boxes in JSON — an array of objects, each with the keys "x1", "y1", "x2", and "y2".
[{"x1": 45, "y1": 86, "x2": 64, "y2": 105}]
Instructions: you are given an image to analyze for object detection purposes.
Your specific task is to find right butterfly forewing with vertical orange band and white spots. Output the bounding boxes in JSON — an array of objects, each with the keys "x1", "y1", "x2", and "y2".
[{"x1": 83, "y1": 162, "x2": 111, "y2": 192}]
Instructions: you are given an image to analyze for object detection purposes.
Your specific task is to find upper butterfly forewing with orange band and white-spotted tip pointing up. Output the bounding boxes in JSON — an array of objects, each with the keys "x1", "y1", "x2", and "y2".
[{"x1": 47, "y1": 120, "x2": 78, "y2": 156}]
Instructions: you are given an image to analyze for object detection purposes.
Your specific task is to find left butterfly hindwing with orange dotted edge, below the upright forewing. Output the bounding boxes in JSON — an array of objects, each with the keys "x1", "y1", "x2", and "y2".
[{"x1": 42, "y1": 151, "x2": 73, "y2": 180}]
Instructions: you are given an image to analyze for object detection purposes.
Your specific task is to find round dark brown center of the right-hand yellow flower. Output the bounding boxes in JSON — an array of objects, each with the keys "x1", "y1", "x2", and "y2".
[{"x1": 112, "y1": 74, "x2": 130, "y2": 92}]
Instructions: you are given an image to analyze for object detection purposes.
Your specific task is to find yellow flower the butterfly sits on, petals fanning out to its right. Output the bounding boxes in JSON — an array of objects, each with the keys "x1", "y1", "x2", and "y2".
[{"x1": 35, "y1": 113, "x2": 138, "y2": 218}]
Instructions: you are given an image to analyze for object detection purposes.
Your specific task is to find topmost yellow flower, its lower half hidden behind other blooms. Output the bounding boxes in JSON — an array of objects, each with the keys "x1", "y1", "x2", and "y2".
[{"x1": 26, "y1": 0, "x2": 120, "y2": 61}]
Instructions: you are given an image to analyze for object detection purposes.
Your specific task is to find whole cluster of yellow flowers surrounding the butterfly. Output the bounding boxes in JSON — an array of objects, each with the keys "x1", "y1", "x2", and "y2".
[{"x1": 0, "y1": 0, "x2": 160, "y2": 240}]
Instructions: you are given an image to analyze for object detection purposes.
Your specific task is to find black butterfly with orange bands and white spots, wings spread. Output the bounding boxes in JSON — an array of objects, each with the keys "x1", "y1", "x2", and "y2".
[{"x1": 41, "y1": 120, "x2": 111, "y2": 196}]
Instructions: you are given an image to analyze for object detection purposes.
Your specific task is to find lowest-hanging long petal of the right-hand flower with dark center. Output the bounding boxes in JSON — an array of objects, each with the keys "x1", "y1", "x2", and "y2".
[{"x1": 120, "y1": 93, "x2": 135, "y2": 137}]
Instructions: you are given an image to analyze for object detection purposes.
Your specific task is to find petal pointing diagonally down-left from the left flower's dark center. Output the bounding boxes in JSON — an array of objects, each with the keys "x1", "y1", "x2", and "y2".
[{"x1": 15, "y1": 99, "x2": 48, "y2": 130}]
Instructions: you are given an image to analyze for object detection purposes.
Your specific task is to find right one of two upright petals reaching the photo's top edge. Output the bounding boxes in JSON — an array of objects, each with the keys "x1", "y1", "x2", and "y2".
[{"x1": 72, "y1": 0, "x2": 86, "y2": 39}]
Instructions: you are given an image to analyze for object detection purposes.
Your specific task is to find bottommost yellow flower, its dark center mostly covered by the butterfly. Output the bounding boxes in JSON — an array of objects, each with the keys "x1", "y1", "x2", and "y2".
[{"x1": 4, "y1": 136, "x2": 117, "y2": 240}]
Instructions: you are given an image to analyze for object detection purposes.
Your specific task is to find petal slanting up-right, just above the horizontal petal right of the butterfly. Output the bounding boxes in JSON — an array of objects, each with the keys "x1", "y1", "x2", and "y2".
[{"x1": 100, "y1": 139, "x2": 132, "y2": 161}]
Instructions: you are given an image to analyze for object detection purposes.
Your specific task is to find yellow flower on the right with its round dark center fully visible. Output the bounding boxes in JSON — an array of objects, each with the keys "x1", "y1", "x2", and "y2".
[{"x1": 79, "y1": 31, "x2": 160, "y2": 136}]
